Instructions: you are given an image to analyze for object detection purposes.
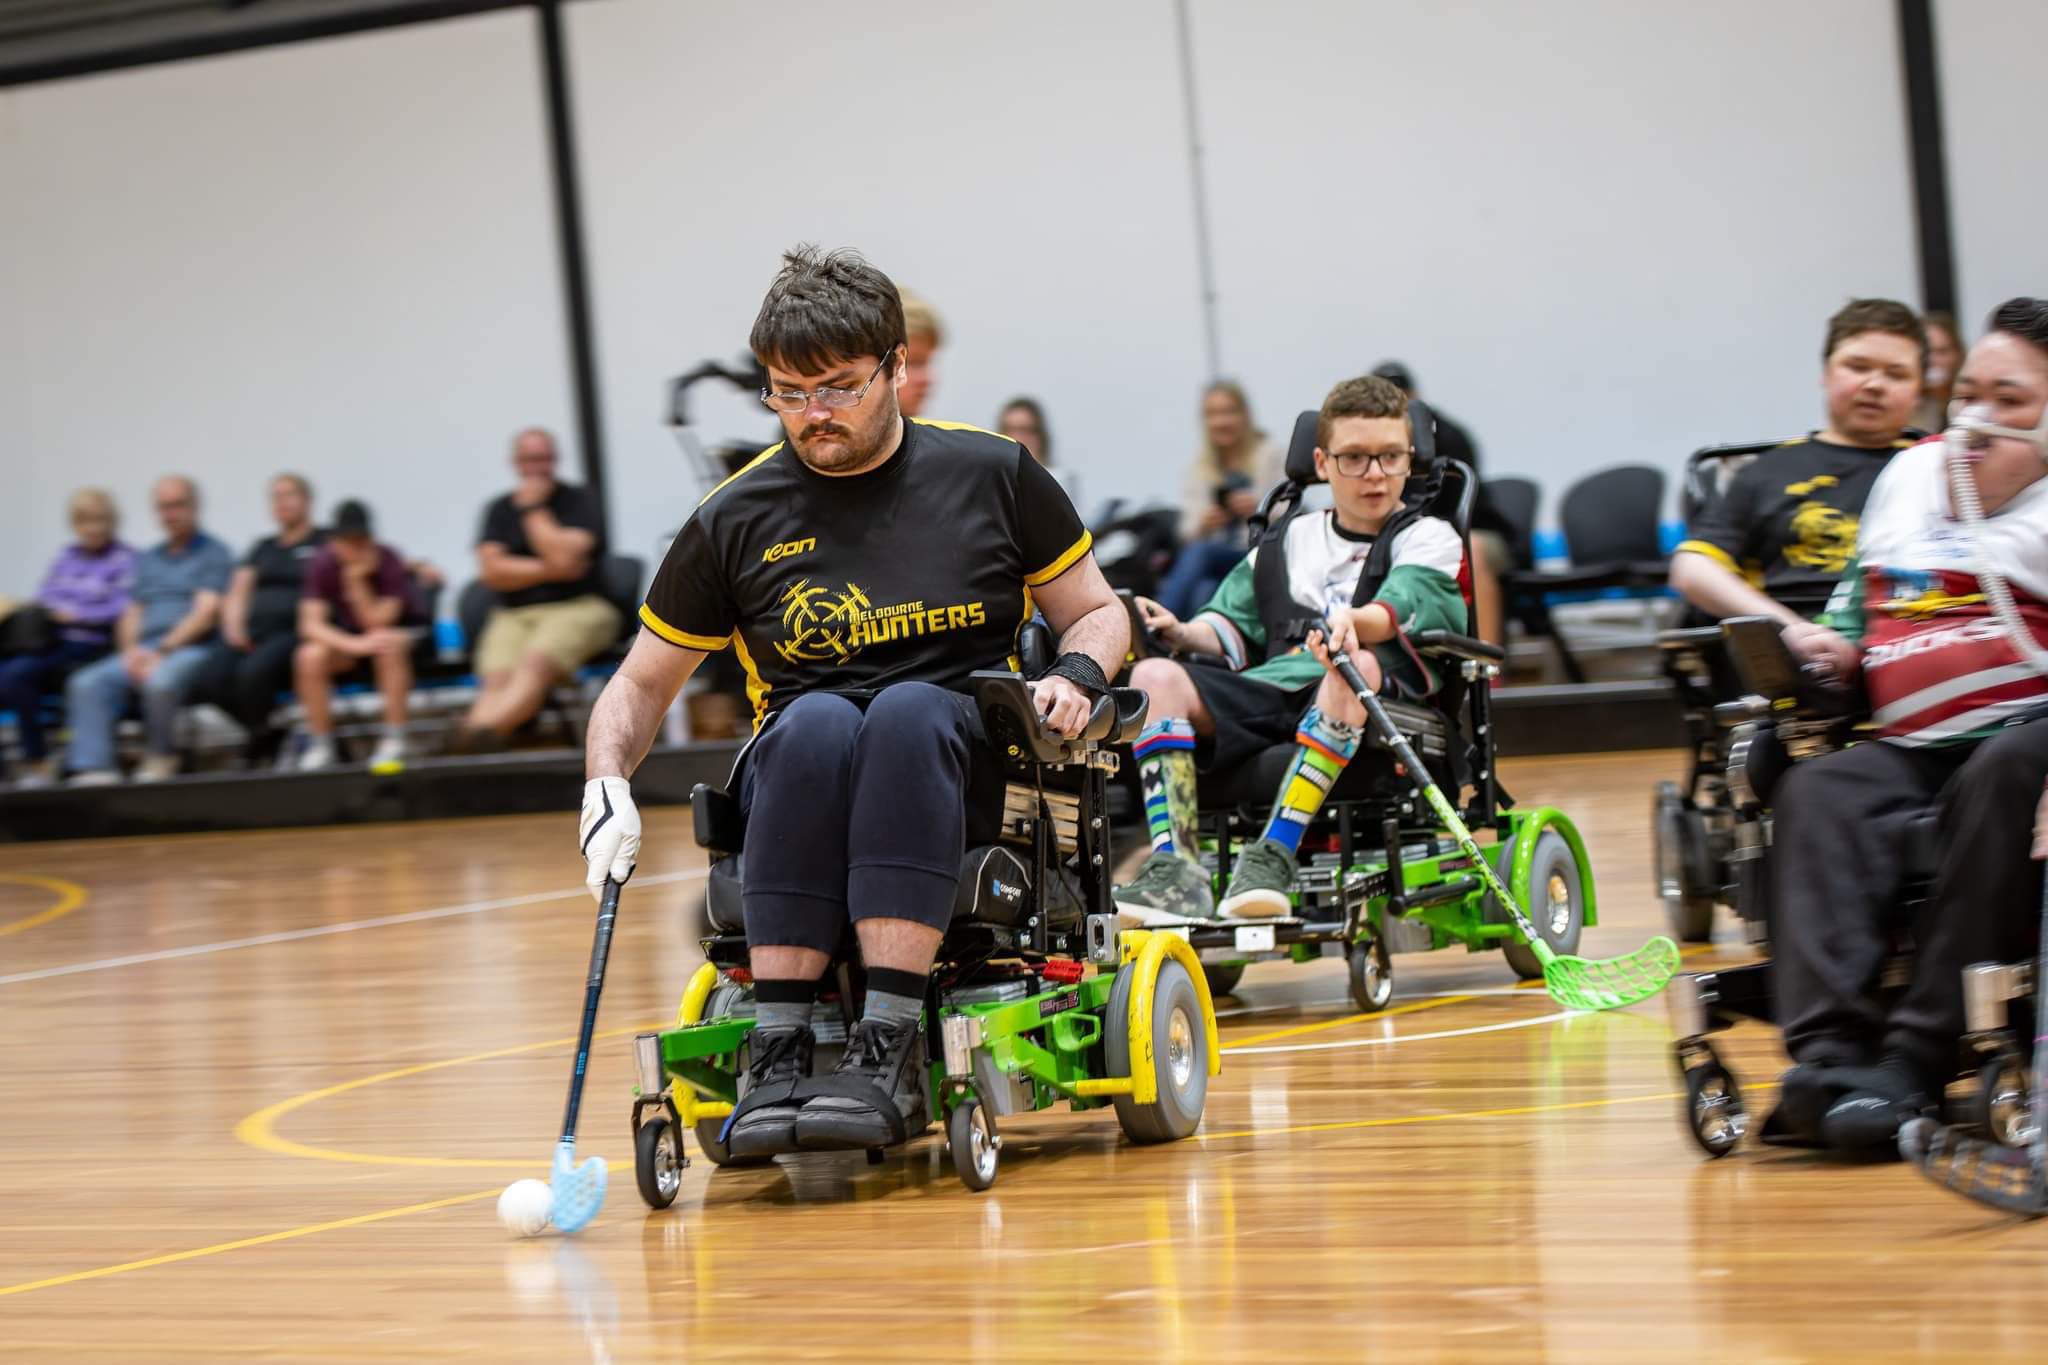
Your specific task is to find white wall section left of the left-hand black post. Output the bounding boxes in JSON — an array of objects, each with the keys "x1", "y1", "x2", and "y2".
[{"x1": 0, "y1": 12, "x2": 571, "y2": 591}]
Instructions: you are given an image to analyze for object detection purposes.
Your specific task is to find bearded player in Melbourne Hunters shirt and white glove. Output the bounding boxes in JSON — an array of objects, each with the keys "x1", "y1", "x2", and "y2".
[{"x1": 580, "y1": 248, "x2": 1130, "y2": 1156}]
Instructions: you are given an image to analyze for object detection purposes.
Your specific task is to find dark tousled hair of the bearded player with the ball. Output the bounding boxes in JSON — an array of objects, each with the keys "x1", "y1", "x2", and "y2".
[{"x1": 748, "y1": 241, "x2": 903, "y2": 375}]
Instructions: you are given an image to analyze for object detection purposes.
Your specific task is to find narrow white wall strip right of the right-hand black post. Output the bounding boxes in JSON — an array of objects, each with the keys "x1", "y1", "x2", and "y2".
[{"x1": 1935, "y1": 0, "x2": 2048, "y2": 338}]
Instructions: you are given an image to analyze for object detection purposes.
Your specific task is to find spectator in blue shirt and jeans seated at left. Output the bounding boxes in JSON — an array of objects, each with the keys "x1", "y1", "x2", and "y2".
[{"x1": 63, "y1": 475, "x2": 236, "y2": 786}]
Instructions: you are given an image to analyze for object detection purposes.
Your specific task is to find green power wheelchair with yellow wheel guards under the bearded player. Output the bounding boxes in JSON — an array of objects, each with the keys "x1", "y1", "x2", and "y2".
[{"x1": 633, "y1": 673, "x2": 1221, "y2": 1209}]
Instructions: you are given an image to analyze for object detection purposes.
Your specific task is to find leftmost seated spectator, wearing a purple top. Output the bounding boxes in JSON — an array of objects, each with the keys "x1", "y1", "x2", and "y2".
[{"x1": 0, "y1": 489, "x2": 135, "y2": 786}]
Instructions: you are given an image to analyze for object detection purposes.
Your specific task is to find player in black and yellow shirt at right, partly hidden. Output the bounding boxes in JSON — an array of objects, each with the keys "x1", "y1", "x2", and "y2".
[{"x1": 1671, "y1": 299, "x2": 1927, "y2": 626}]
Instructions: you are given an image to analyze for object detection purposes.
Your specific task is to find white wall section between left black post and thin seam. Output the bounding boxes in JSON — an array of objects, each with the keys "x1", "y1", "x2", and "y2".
[{"x1": 567, "y1": 0, "x2": 1202, "y2": 564}]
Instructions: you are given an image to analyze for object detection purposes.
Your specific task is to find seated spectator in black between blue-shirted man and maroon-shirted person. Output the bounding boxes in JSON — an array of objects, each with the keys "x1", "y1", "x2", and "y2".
[{"x1": 193, "y1": 475, "x2": 328, "y2": 763}]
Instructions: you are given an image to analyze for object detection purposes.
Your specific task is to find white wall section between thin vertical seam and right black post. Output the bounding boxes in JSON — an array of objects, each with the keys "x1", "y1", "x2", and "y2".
[{"x1": 1194, "y1": 0, "x2": 1917, "y2": 516}]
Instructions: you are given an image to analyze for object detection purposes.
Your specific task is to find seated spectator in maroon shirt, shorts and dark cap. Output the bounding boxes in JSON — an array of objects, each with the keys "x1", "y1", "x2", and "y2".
[{"x1": 293, "y1": 501, "x2": 414, "y2": 772}]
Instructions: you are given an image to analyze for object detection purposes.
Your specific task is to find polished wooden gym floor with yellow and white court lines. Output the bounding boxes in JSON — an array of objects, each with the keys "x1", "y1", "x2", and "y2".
[{"x1": 0, "y1": 753, "x2": 2048, "y2": 1361}]
